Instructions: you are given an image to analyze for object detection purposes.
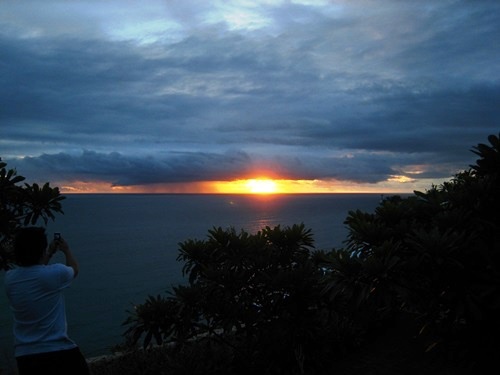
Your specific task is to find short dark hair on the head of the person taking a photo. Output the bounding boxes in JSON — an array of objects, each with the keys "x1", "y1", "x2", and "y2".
[{"x1": 14, "y1": 227, "x2": 48, "y2": 266}]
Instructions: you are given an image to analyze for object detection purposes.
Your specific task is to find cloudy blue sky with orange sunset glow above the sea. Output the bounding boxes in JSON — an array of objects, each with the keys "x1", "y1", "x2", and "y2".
[{"x1": 0, "y1": 0, "x2": 500, "y2": 193}]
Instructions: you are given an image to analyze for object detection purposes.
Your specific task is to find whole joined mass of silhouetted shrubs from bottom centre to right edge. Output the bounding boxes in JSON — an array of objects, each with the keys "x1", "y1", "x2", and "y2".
[{"x1": 125, "y1": 135, "x2": 500, "y2": 374}]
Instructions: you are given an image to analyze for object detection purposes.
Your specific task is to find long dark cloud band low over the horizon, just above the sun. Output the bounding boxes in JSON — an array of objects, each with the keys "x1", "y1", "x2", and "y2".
[{"x1": 13, "y1": 147, "x2": 439, "y2": 186}]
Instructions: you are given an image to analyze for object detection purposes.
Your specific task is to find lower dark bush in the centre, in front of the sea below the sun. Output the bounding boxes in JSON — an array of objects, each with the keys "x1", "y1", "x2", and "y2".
[{"x1": 125, "y1": 224, "x2": 364, "y2": 373}]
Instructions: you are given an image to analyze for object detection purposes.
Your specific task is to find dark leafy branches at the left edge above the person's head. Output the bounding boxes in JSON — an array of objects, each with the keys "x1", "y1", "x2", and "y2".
[{"x1": 0, "y1": 159, "x2": 64, "y2": 270}]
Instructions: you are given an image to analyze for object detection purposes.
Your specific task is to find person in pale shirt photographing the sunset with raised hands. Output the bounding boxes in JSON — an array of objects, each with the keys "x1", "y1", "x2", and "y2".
[{"x1": 5, "y1": 227, "x2": 89, "y2": 375}]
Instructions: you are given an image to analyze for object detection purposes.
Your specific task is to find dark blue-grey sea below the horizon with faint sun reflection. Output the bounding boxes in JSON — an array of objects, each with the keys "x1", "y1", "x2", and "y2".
[{"x1": 0, "y1": 194, "x2": 381, "y2": 368}]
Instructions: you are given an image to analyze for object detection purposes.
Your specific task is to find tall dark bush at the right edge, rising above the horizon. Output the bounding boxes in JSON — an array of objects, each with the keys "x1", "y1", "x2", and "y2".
[{"x1": 326, "y1": 135, "x2": 500, "y2": 359}]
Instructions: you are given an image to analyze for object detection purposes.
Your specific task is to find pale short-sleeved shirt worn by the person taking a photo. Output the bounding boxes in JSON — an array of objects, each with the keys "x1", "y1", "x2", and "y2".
[{"x1": 5, "y1": 264, "x2": 76, "y2": 357}]
